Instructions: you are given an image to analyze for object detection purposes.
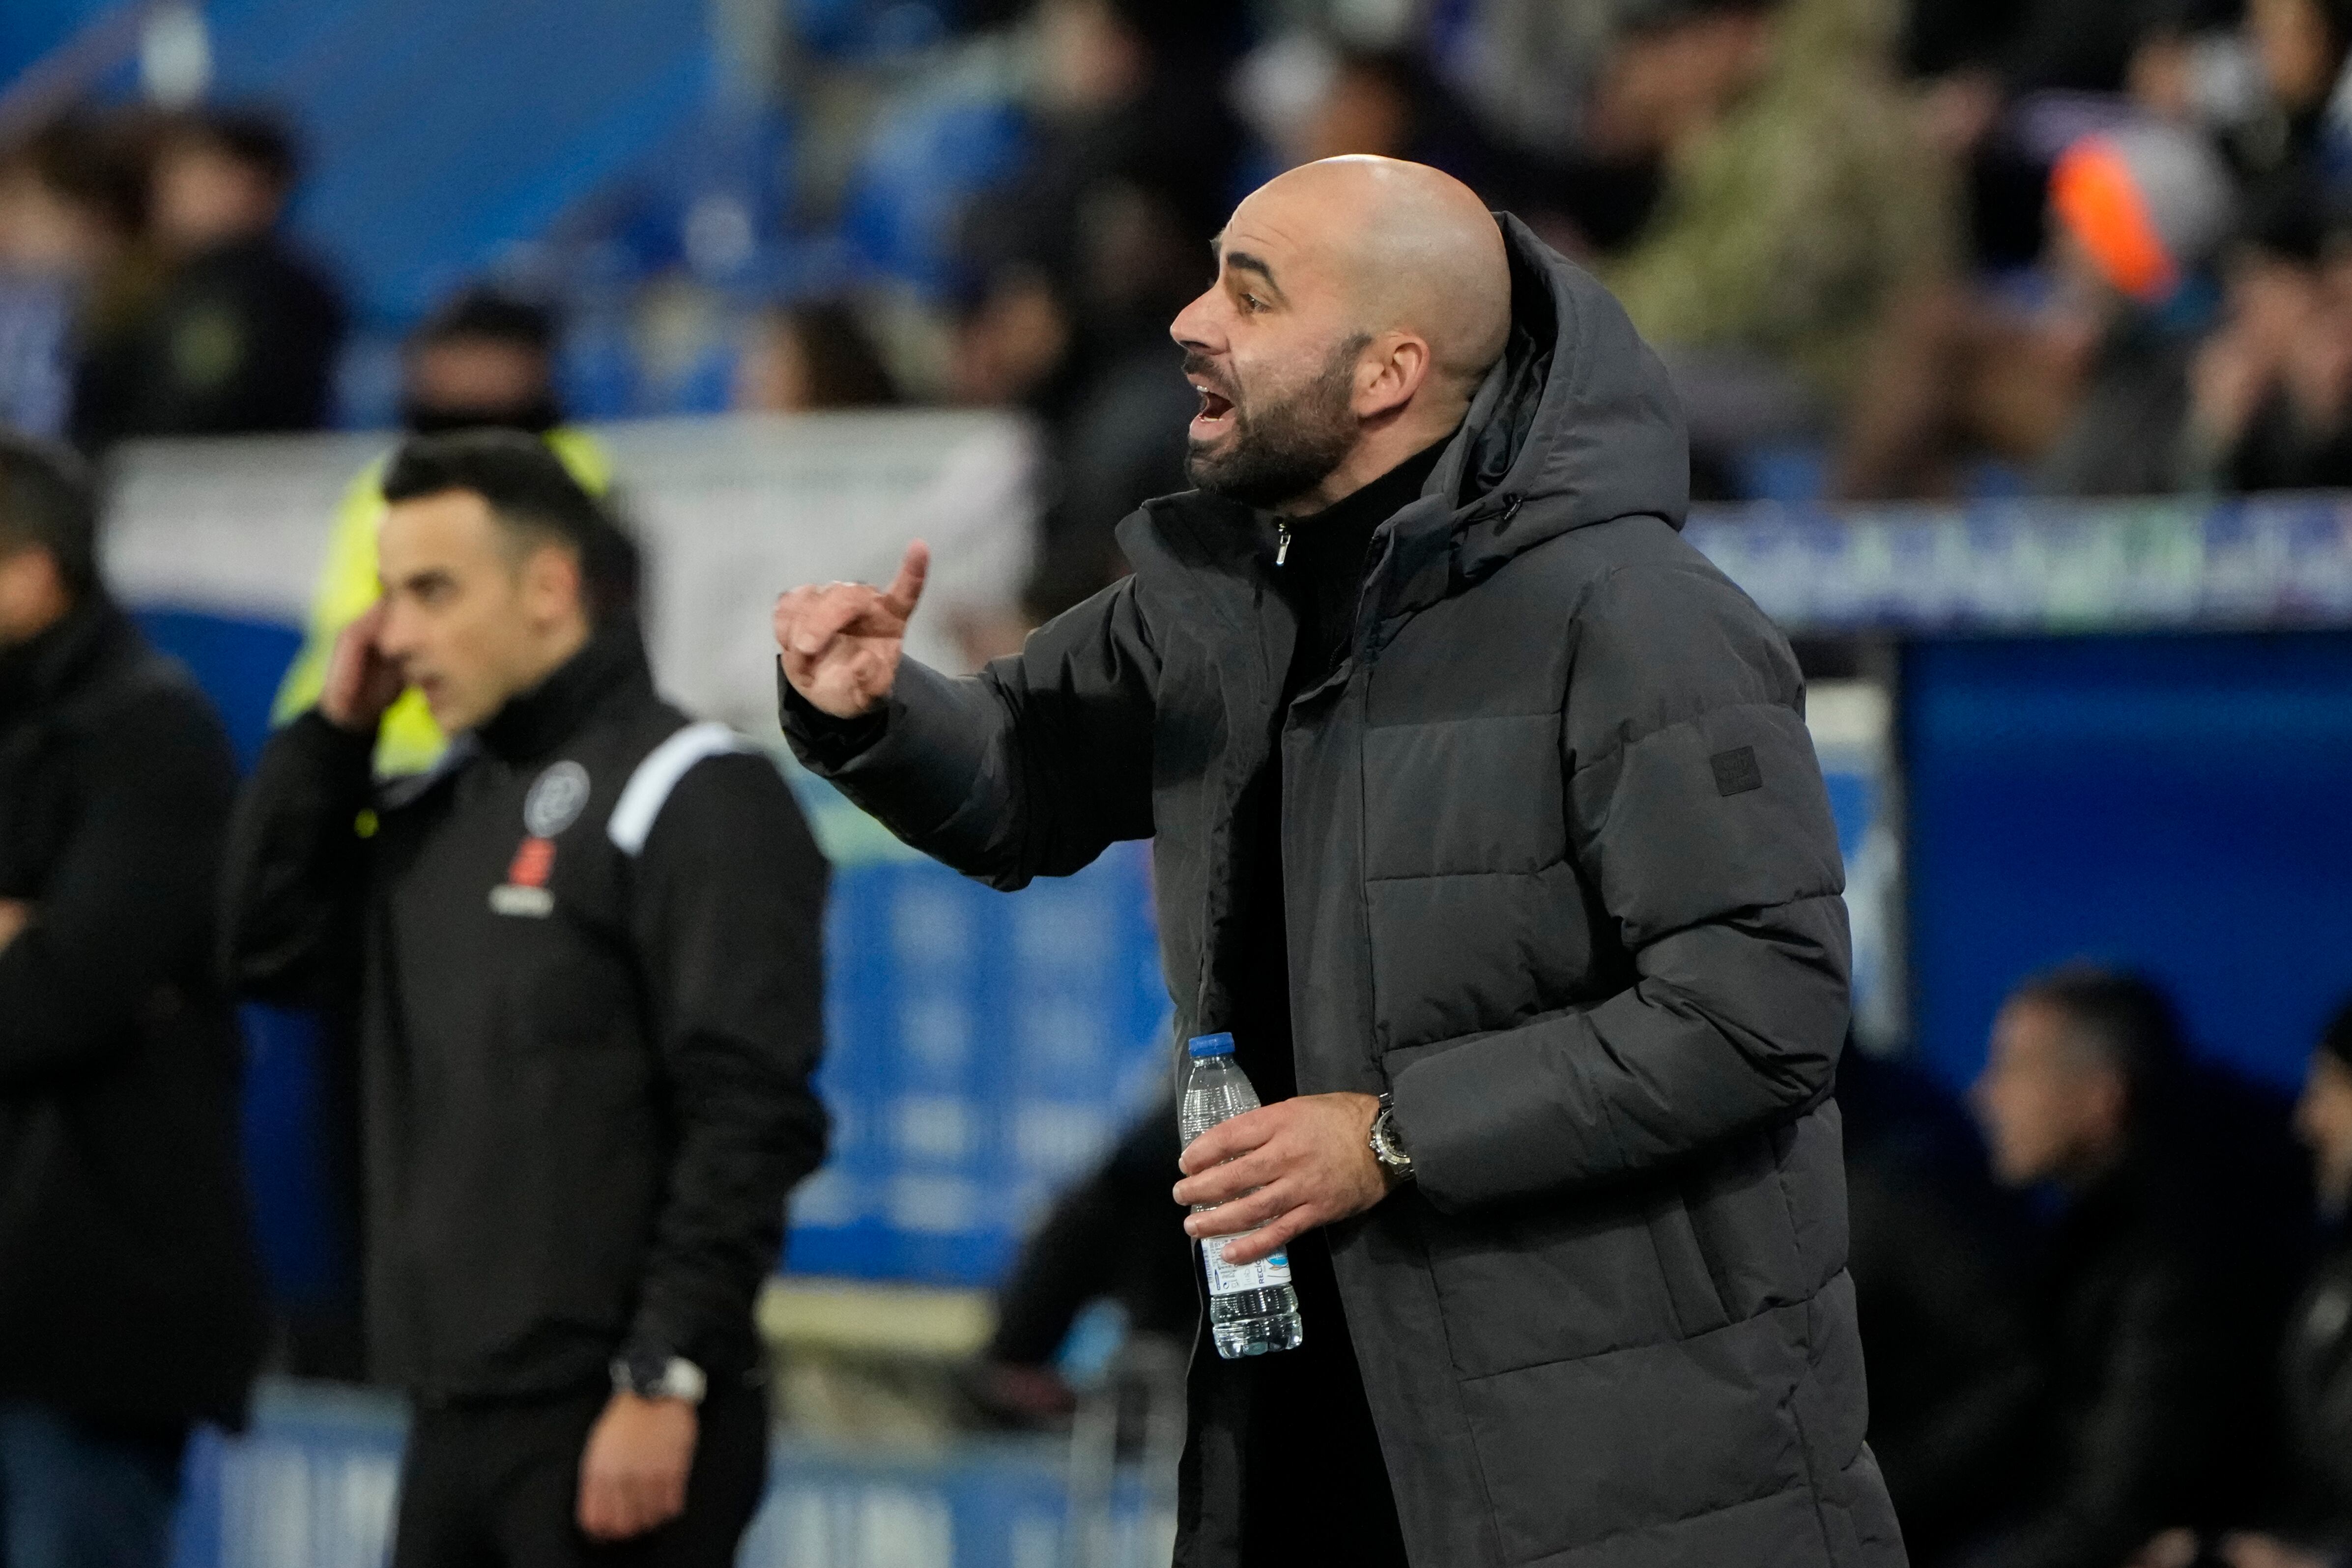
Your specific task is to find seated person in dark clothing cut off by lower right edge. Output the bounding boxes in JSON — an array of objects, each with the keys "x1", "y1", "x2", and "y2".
[{"x1": 2133, "y1": 1006, "x2": 2352, "y2": 1568}]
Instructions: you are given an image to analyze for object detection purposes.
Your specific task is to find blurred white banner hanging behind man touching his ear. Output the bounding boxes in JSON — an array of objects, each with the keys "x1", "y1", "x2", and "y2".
[{"x1": 106, "y1": 411, "x2": 1035, "y2": 736}]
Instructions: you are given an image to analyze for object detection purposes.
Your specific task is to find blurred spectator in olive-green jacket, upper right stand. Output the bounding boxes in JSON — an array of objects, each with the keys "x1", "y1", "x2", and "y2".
[{"x1": 1595, "y1": 0, "x2": 1952, "y2": 496}]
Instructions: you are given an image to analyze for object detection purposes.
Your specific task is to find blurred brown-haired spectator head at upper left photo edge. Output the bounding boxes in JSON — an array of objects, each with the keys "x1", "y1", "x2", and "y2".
[{"x1": 0, "y1": 115, "x2": 146, "y2": 273}]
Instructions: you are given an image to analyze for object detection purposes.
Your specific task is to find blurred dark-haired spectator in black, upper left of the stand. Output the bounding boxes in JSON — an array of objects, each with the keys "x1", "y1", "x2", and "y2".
[{"x1": 73, "y1": 113, "x2": 344, "y2": 449}]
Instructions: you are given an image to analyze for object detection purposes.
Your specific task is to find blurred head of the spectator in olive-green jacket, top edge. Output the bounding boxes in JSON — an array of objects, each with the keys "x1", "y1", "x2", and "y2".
[{"x1": 1590, "y1": 0, "x2": 1783, "y2": 158}]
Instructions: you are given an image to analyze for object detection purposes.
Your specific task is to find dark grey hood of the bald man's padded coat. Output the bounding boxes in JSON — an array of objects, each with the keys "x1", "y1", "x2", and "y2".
[{"x1": 1430, "y1": 214, "x2": 1691, "y2": 557}]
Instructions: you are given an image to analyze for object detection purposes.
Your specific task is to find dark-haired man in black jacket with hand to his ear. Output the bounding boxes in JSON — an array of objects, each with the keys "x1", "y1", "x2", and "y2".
[{"x1": 228, "y1": 430, "x2": 826, "y2": 1568}]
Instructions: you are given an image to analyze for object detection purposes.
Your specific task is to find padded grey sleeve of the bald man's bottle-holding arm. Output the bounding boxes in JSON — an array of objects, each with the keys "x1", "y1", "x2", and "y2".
[{"x1": 1395, "y1": 562, "x2": 1849, "y2": 1208}]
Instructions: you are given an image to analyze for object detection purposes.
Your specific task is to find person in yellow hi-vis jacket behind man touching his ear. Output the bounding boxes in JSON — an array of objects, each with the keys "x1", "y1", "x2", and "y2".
[{"x1": 270, "y1": 289, "x2": 611, "y2": 776}]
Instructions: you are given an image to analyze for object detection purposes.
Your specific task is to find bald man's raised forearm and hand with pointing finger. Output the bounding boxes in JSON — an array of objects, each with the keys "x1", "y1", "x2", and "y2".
[{"x1": 776, "y1": 545, "x2": 1157, "y2": 888}]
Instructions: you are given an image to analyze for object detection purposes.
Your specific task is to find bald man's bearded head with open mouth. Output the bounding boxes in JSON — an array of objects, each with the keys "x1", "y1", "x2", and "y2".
[{"x1": 1171, "y1": 158, "x2": 1510, "y2": 513}]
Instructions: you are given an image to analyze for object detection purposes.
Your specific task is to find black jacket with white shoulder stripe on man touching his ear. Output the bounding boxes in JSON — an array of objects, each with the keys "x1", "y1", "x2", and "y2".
[{"x1": 224, "y1": 623, "x2": 826, "y2": 1403}]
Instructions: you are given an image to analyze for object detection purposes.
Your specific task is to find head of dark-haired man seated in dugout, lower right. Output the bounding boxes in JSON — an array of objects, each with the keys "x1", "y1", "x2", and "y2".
[{"x1": 1971, "y1": 966, "x2": 2180, "y2": 1187}]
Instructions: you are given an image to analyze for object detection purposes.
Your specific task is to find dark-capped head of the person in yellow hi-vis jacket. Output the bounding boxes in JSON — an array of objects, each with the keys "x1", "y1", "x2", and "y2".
[{"x1": 400, "y1": 289, "x2": 565, "y2": 435}]
